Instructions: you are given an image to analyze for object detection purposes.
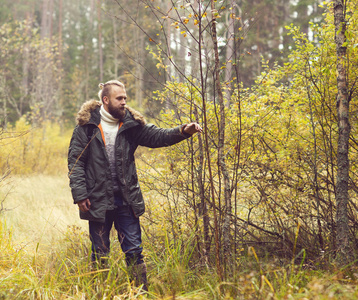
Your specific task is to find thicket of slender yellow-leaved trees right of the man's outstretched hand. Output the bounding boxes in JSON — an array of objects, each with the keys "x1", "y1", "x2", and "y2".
[{"x1": 136, "y1": 0, "x2": 358, "y2": 272}]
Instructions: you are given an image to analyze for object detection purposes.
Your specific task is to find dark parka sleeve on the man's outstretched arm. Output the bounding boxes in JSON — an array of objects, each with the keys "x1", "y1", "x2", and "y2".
[{"x1": 135, "y1": 124, "x2": 191, "y2": 148}]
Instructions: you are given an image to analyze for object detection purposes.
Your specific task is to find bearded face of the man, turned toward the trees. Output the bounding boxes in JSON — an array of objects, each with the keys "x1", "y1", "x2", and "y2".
[{"x1": 103, "y1": 85, "x2": 127, "y2": 120}]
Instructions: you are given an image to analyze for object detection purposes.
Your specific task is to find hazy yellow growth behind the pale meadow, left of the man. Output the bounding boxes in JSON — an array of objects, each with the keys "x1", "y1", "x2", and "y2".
[{"x1": 0, "y1": 116, "x2": 72, "y2": 175}]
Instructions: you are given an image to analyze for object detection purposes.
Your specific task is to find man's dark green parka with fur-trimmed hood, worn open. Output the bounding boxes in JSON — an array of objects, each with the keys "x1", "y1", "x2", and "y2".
[{"x1": 68, "y1": 100, "x2": 190, "y2": 222}]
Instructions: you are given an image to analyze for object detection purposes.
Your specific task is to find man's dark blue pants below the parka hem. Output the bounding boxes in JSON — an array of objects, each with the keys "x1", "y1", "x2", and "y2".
[{"x1": 89, "y1": 205, "x2": 143, "y2": 265}]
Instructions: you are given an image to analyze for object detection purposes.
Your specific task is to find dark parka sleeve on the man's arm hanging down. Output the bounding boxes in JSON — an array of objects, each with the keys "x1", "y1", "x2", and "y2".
[{"x1": 68, "y1": 126, "x2": 88, "y2": 203}]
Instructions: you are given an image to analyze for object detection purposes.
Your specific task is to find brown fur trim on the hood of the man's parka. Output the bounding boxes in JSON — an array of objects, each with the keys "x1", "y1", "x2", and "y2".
[{"x1": 76, "y1": 100, "x2": 147, "y2": 126}]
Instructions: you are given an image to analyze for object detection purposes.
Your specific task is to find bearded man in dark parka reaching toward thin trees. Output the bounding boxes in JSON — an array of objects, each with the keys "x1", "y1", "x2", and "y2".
[{"x1": 68, "y1": 80, "x2": 202, "y2": 290}]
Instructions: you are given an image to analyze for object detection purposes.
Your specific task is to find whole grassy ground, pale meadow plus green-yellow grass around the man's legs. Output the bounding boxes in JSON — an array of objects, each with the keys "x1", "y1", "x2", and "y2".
[{"x1": 0, "y1": 175, "x2": 358, "y2": 299}]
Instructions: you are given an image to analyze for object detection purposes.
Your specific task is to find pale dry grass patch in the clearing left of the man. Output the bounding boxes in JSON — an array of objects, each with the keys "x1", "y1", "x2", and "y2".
[{"x1": 2, "y1": 174, "x2": 87, "y2": 251}]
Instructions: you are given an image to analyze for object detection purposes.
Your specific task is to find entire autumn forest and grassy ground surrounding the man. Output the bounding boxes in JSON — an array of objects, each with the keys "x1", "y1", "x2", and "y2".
[{"x1": 0, "y1": 0, "x2": 358, "y2": 299}]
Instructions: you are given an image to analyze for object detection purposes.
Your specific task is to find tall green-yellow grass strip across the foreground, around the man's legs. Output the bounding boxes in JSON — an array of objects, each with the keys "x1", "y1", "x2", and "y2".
[{"x1": 0, "y1": 219, "x2": 358, "y2": 299}]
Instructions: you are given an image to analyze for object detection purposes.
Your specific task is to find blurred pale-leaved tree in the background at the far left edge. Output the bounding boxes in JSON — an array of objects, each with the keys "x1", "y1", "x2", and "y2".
[{"x1": 0, "y1": 21, "x2": 59, "y2": 126}]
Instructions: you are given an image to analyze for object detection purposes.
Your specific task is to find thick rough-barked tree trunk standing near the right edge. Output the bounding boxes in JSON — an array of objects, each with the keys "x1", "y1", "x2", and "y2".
[{"x1": 333, "y1": 0, "x2": 352, "y2": 266}]
